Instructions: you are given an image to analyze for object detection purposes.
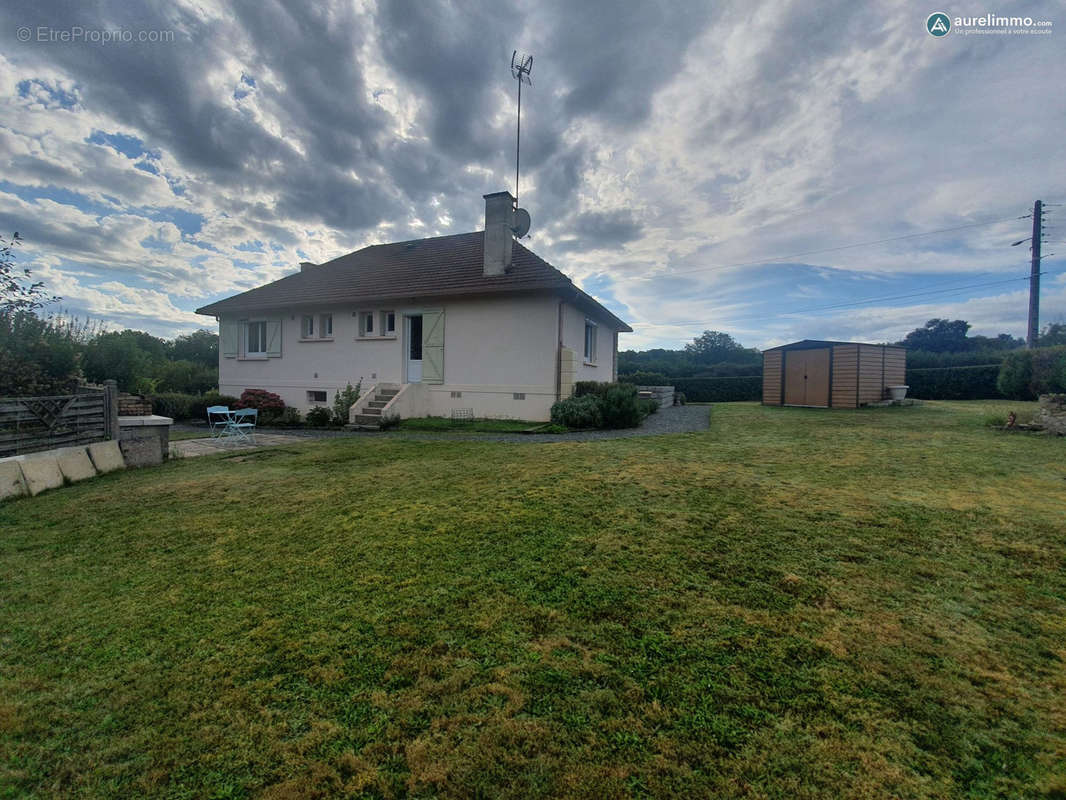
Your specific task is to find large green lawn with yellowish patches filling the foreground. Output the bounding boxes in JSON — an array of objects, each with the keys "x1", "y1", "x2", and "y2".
[{"x1": 0, "y1": 402, "x2": 1066, "y2": 798}]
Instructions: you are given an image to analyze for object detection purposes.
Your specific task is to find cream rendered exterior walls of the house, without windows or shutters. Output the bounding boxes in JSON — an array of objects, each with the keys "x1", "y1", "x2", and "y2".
[{"x1": 212, "y1": 294, "x2": 571, "y2": 420}]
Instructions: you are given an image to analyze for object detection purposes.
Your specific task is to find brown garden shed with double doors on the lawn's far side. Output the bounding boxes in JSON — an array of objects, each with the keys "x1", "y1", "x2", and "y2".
[{"x1": 762, "y1": 339, "x2": 907, "y2": 409}]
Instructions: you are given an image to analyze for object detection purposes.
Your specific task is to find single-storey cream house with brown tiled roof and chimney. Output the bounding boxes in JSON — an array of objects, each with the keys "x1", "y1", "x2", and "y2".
[{"x1": 196, "y1": 192, "x2": 632, "y2": 422}]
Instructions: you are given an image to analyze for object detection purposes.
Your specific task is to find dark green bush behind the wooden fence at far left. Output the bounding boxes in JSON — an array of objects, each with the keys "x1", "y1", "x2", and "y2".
[{"x1": 0, "y1": 310, "x2": 81, "y2": 397}]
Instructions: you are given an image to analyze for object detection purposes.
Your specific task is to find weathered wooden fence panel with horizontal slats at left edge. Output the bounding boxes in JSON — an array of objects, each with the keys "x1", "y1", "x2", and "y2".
[{"x1": 0, "y1": 387, "x2": 117, "y2": 458}]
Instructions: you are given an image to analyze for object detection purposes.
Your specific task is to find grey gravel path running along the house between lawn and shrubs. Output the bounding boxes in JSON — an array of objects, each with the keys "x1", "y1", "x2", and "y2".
[{"x1": 172, "y1": 405, "x2": 711, "y2": 444}]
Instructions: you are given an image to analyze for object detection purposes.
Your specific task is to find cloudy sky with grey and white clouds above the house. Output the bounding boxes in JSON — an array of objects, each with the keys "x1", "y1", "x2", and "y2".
[{"x1": 0, "y1": 0, "x2": 1066, "y2": 349}]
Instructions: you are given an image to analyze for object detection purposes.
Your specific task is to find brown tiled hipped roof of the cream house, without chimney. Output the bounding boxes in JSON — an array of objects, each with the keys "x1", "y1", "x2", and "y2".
[{"x1": 196, "y1": 231, "x2": 632, "y2": 331}]
